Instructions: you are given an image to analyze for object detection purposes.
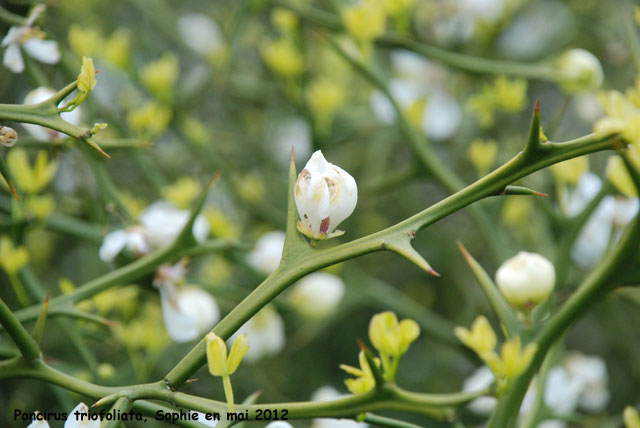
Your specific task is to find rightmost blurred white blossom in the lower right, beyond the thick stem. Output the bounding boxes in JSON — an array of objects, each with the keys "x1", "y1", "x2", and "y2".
[{"x1": 565, "y1": 352, "x2": 611, "y2": 412}]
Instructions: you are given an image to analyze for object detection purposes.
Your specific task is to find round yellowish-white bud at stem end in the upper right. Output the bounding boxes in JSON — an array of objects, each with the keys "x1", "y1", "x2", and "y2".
[{"x1": 556, "y1": 49, "x2": 604, "y2": 92}]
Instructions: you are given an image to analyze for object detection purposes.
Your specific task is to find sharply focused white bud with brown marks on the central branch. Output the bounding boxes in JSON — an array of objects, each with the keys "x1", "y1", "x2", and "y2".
[{"x1": 295, "y1": 150, "x2": 358, "y2": 239}]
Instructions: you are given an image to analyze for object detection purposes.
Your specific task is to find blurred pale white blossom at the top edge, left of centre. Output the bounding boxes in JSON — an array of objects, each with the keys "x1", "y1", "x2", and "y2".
[{"x1": 178, "y1": 13, "x2": 224, "y2": 57}]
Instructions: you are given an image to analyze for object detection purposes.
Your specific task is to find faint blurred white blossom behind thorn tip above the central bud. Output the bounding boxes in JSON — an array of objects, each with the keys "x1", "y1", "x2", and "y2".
[{"x1": 270, "y1": 117, "x2": 313, "y2": 166}]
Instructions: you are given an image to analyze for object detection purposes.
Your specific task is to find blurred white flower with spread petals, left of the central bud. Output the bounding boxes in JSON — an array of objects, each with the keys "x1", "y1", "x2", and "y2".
[{"x1": 100, "y1": 201, "x2": 209, "y2": 262}]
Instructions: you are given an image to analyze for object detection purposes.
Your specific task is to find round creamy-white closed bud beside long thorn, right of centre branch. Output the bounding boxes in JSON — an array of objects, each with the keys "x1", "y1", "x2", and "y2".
[{"x1": 496, "y1": 251, "x2": 556, "y2": 309}]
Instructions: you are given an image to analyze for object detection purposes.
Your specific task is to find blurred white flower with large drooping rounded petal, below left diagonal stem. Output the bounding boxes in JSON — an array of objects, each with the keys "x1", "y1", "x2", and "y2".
[{"x1": 153, "y1": 261, "x2": 220, "y2": 342}]
